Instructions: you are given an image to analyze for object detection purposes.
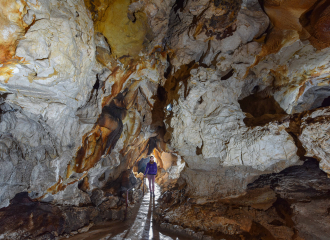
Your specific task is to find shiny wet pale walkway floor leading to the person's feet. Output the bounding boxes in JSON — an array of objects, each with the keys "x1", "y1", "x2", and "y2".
[{"x1": 62, "y1": 183, "x2": 192, "y2": 240}]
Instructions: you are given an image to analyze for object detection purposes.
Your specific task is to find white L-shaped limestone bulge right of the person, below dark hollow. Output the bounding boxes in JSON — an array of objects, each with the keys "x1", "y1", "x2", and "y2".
[{"x1": 169, "y1": 67, "x2": 299, "y2": 195}]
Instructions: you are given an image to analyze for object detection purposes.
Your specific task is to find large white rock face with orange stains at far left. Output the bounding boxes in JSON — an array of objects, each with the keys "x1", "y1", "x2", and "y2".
[{"x1": 0, "y1": 0, "x2": 101, "y2": 207}]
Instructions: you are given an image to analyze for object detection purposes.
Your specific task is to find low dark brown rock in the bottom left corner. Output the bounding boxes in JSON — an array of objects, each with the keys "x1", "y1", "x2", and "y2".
[{"x1": 0, "y1": 192, "x2": 99, "y2": 239}]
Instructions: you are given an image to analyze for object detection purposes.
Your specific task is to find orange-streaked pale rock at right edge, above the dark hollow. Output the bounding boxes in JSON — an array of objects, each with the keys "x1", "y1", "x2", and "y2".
[{"x1": 251, "y1": 40, "x2": 330, "y2": 113}]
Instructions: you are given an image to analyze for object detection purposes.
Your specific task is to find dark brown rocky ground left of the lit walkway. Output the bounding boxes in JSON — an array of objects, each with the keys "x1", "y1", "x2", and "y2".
[{"x1": 0, "y1": 171, "x2": 147, "y2": 239}]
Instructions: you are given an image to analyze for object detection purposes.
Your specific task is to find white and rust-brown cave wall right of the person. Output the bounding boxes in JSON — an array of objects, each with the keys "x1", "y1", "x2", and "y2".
[{"x1": 165, "y1": 1, "x2": 329, "y2": 201}]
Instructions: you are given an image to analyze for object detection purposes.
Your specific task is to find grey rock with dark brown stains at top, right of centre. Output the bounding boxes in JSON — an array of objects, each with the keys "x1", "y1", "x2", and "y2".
[{"x1": 167, "y1": 0, "x2": 269, "y2": 67}]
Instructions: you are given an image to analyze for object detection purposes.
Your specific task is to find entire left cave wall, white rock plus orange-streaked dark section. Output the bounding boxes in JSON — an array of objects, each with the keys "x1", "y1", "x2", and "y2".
[{"x1": 0, "y1": 1, "x2": 169, "y2": 207}]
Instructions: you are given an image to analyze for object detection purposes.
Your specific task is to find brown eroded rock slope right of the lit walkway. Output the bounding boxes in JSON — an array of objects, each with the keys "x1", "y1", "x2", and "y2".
[{"x1": 157, "y1": 159, "x2": 330, "y2": 239}]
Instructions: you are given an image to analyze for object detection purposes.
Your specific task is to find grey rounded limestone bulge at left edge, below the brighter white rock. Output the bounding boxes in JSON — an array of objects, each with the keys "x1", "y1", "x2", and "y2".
[{"x1": 0, "y1": 102, "x2": 58, "y2": 207}]
